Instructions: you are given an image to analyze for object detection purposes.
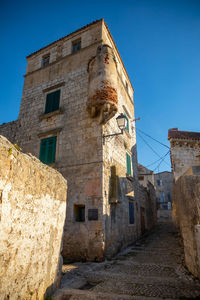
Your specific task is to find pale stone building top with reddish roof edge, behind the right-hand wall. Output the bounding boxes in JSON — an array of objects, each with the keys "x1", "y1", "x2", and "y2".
[{"x1": 168, "y1": 128, "x2": 200, "y2": 180}]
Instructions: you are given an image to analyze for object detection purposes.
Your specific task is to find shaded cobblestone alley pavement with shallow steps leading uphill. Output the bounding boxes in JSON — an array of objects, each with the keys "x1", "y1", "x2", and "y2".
[{"x1": 53, "y1": 222, "x2": 200, "y2": 300}]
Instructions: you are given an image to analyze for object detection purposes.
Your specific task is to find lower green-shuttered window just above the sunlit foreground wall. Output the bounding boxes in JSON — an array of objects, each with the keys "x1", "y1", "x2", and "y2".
[{"x1": 40, "y1": 136, "x2": 57, "y2": 164}]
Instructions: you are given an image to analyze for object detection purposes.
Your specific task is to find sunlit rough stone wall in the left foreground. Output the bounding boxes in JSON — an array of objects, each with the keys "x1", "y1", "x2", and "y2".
[{"x1": 0, "y1": 136, "x2": 67, "y2": 300}]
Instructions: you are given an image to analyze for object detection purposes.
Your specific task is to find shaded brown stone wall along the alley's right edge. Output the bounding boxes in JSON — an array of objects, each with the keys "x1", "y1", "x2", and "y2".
[{"x1": 173, "y1": 174, "x2": 200, "y2": 278}]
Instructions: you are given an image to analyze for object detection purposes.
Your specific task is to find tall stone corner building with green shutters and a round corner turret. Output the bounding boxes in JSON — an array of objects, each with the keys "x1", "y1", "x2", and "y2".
[{"x1": 0, "y1": 19, "x2": 156, "y2": 261}]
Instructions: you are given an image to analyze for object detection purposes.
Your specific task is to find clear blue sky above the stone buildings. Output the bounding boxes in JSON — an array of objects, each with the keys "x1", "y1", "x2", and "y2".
[{"x1": 0, "y1": 0, "x2": 200, "y2": 171}]
